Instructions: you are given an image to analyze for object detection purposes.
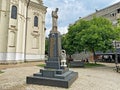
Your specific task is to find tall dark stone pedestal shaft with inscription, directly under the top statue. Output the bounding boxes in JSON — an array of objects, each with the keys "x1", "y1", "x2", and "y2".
[{"x1": 45, "y1": 30, "x2": 61, "y2": 69}]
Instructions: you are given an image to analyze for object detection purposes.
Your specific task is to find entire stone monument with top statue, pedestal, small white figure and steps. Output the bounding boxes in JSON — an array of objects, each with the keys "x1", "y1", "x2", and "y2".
[{"x1": 26, "y1": 8, "x2": 78, "y2": 88}]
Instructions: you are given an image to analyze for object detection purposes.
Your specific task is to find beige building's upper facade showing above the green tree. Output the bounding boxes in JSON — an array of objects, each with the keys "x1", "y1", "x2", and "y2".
[{"x1": 82, "y1": 2, "x2": 120, "y2": 25}]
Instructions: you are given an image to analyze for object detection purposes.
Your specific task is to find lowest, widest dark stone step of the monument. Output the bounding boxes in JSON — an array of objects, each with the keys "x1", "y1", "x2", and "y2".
[{"x1": 26, "y1": 72, "x2": 78, "y2": 88}]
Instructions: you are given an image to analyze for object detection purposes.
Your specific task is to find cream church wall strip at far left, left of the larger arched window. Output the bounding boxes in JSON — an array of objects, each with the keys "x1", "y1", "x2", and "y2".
[{"x1": 0, "y1": 0, "x2": 9, "y2": 61}]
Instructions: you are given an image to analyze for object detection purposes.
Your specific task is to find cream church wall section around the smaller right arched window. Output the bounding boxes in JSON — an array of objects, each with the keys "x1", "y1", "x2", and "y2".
[{"x1": 27, "y1": 6, "x2": 45, "y2": 60}]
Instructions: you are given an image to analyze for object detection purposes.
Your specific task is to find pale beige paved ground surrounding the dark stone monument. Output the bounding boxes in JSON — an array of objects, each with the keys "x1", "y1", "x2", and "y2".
[{"x1": 0, "y1": 64, "x2": 120, "y2": 90}]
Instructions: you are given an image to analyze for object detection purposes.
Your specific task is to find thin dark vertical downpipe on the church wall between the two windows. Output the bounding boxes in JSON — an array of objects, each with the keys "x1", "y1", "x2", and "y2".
[{"x1": 24, "y1": 0, "x2": 30, "y2": 62}]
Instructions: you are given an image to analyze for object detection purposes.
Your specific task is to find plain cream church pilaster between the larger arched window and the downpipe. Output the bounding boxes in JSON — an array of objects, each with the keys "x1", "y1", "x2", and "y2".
[{"x1": 16, "y1": 0, "x2": 26, "y2": 60}]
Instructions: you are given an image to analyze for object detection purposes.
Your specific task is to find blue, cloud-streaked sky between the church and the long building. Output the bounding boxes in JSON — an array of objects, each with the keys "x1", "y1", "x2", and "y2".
[{"x1": 43, "y1": 0, "x2": 120, "y2": 36}]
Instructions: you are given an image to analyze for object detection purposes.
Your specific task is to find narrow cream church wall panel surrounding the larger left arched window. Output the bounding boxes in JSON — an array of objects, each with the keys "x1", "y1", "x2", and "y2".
[{"x1": 6, "y1": 0, "x2": 19, "y2": 61}]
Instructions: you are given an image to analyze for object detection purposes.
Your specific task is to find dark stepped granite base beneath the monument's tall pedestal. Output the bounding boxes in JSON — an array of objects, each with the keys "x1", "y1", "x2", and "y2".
[{"x1": 26, "y1": 69, "x2": 78, "y2": 88}]
